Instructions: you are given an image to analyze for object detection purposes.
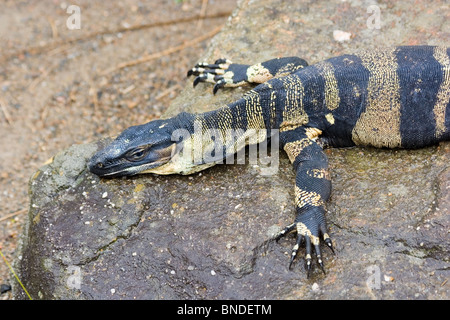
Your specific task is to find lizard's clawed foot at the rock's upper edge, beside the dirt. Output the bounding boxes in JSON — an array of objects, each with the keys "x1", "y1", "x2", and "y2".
[{"x1": 187, "y1": 59, "x2": 248, "y2": 94}]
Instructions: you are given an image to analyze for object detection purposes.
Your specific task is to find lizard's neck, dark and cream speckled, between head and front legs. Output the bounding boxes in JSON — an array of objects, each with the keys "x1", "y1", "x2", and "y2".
[{"x1": 171, "y1": 90, "x2": 271, "y2": 166}]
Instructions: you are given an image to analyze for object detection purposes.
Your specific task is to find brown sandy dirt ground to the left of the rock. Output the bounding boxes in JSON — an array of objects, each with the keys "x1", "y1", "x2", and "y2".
[{"x1": 0, "y1": 0, "x2": 236, "y2": 300}]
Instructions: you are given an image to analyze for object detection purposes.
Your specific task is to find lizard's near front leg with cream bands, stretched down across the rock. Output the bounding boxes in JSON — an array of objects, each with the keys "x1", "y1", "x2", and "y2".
[{"x1": 275, "y1": 127, "x2": 334, "y2": 276}]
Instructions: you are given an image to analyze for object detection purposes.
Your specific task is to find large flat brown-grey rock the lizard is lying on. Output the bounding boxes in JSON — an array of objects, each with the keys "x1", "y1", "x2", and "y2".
[{"x1": 13, "y1": 0, "x2": 450, "y2": 299}]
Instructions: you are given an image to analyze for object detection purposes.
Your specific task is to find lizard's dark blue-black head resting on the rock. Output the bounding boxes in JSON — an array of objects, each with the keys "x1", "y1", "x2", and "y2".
[{"x1": 88, "y1": 118, "x2": 177, "y2": 177}]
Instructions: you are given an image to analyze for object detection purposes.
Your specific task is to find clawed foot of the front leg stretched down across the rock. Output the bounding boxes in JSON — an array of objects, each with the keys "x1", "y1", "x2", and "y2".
[{"x1": 275, "y1": 222, "x2": 334, "y2": 278}]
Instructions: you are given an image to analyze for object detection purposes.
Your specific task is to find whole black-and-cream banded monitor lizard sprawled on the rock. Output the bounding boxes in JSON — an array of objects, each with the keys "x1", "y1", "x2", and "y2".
[{"x1": 89, "y1": 46, "x2": 450, "y2": 274}]
